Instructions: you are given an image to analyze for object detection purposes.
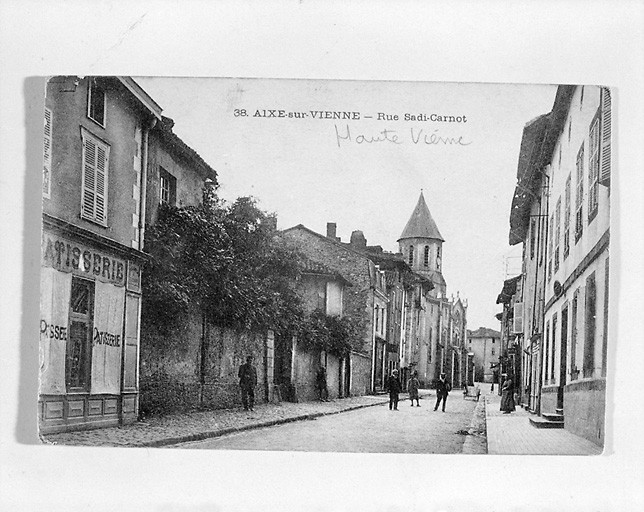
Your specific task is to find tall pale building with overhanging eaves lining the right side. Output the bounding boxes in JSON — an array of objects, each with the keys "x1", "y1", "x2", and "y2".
[{"x1": 510, "y1": 86, "x2": 613, "y2": 445}]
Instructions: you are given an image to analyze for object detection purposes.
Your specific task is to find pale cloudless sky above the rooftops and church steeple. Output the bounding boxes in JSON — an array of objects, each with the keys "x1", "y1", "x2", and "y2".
[{"x1": 136, "y1": 77, "x2": 556, "y2": 330}]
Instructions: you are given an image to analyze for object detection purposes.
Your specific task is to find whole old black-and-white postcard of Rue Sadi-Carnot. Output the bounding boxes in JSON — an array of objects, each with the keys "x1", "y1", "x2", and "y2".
[{"x1": 34, "y1": 75, "x2": 616, "y2": 455}]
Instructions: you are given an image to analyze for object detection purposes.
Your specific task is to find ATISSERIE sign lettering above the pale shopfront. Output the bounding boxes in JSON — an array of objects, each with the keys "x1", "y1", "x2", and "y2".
[{"x1": 43, "y1": 234, "x2": 125, "y2": 286}]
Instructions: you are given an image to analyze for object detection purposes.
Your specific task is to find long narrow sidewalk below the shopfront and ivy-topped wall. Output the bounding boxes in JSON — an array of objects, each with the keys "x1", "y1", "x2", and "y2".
[{"x1": 42, "y1": 390, "x2": 429, "y2": 447}]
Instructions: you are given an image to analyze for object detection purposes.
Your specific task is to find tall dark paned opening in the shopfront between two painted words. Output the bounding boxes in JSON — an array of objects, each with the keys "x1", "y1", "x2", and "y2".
[{"x1": 65, "y1": 277, "x2": 94, "y2": 391}]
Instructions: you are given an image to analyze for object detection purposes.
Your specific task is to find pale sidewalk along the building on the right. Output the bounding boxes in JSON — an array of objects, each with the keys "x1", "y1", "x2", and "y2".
[{"x1": 481, "y1": 384, "x2": 602, "y2": 455}]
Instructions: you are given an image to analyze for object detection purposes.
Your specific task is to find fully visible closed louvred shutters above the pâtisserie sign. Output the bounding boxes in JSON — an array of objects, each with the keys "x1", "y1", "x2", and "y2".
[{"x1": 81, "y1": 130, "x2": 110, "y2": 226}]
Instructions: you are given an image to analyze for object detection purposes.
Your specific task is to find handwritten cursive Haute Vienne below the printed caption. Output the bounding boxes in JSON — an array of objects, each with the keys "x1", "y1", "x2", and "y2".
[{"x1": 334, "y1": 124, "x2": 472, "y2": 148}]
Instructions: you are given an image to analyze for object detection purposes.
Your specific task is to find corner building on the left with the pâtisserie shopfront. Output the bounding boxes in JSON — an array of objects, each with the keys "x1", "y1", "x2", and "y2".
[{"x1": 38, "y1": 76, "x2": 161, "y2": 433}]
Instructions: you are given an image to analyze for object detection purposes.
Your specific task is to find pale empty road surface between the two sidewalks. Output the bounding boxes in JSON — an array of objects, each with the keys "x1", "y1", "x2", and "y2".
[{"x1": 172, "y1": 392, "x2": 476, "y2": 454}]
